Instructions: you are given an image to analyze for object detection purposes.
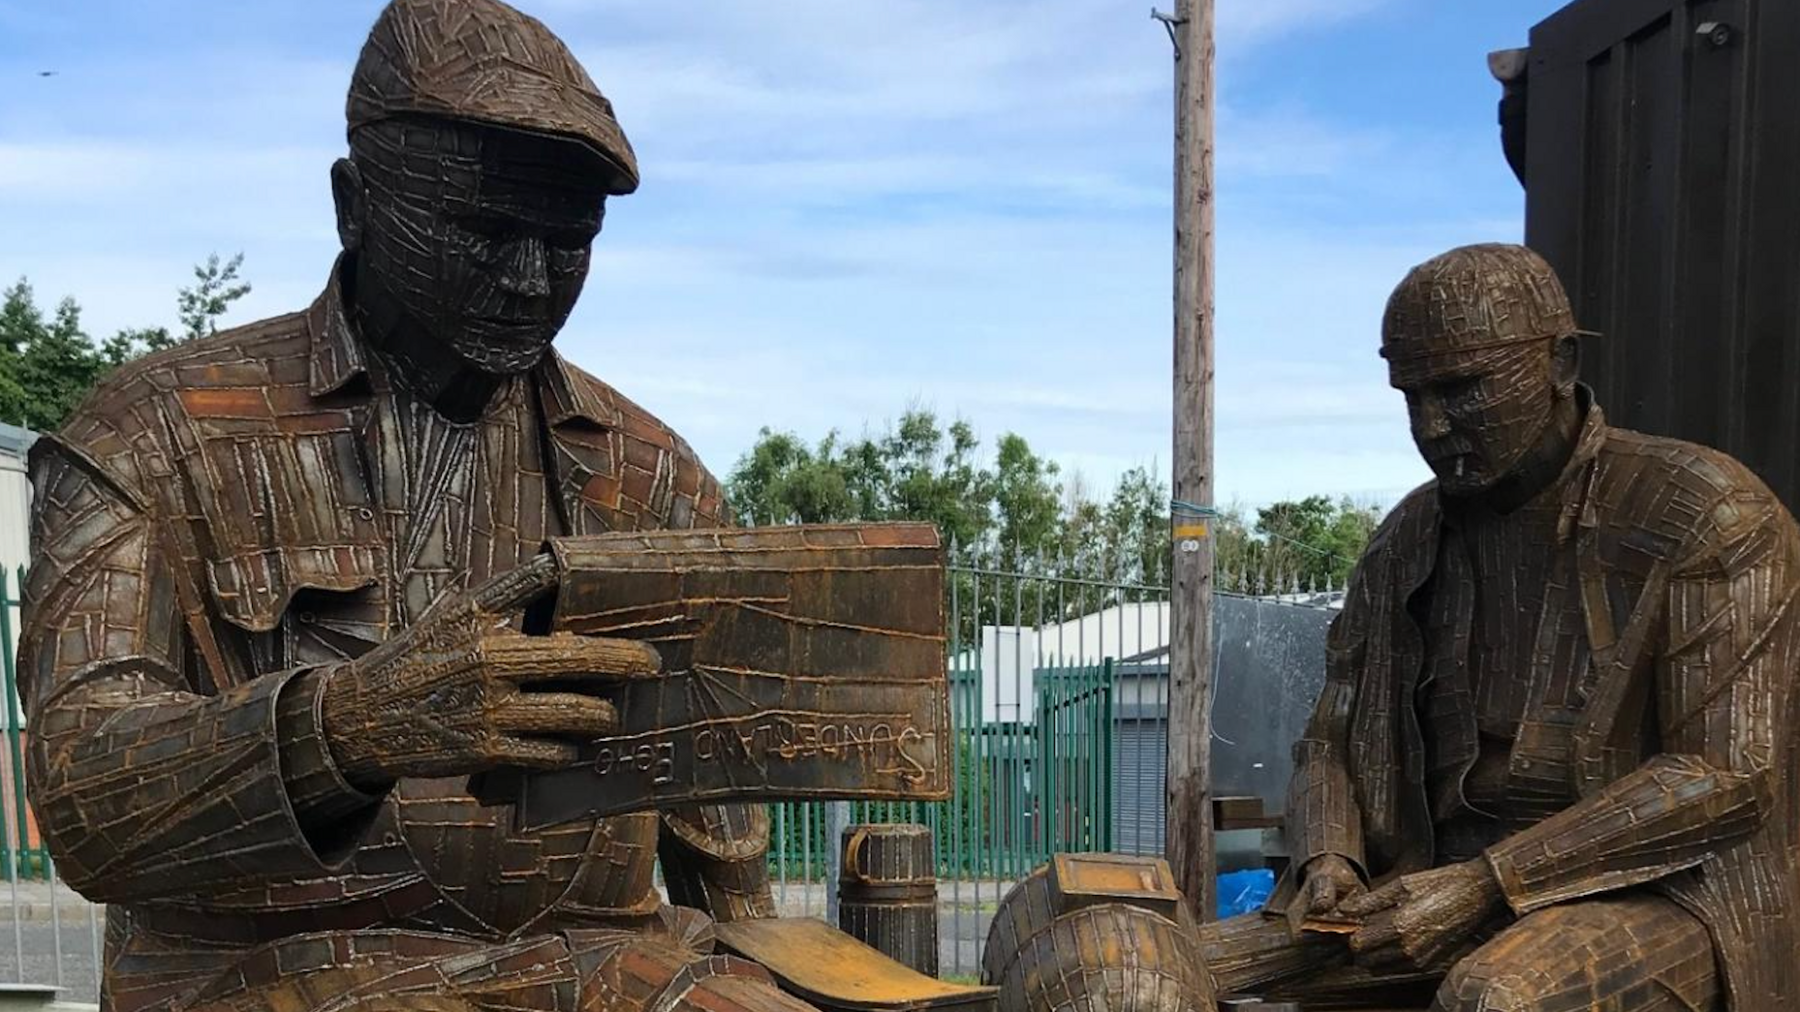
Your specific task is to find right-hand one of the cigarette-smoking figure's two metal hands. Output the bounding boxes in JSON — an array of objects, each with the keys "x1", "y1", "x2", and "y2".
[{"x1": 1341, "y1": 859, "x2": 1505, "y2": 971}]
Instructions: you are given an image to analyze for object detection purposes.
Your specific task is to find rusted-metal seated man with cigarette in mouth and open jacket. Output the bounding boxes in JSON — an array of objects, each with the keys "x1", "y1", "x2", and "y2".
[{"x1": 1202, "y1": 245, "x2": 1800, "y2": 1012}]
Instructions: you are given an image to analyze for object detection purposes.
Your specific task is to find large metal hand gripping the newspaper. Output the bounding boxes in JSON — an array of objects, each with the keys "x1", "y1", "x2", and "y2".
[{"x1": 322, "y1": 558, "x2": 662, "y2": 789}]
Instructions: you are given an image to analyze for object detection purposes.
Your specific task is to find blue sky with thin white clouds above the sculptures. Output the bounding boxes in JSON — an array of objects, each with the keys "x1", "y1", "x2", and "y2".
[{"x1": 0, "y1": 0, "x2": 1559, "y2": 504}]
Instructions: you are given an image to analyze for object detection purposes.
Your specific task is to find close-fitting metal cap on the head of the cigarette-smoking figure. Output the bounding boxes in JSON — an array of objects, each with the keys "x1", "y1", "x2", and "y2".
[{"x1": 1381, "y1": 243, "x2": 1582, "y2": 378}]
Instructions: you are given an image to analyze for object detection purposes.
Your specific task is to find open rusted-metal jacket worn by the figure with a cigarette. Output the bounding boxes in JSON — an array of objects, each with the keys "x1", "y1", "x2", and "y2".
[{"x1": 1289, "y1": 397, "x2": 1800, "y2": 1012}]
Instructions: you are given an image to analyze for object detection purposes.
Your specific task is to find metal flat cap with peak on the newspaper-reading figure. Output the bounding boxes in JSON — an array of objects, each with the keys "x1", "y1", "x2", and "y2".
[{"x1": 346, "y1": 0, "x2": 637, "y2": 194}]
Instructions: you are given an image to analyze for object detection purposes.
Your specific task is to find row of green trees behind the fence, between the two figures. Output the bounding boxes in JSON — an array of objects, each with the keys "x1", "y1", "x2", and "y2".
[{"x1": 725, "y1": 407, "x2": 1379, "y2": 601}]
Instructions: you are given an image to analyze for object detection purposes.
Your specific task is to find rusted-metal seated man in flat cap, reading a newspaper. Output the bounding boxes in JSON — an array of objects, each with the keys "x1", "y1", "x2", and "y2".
[{"x1": 20, "y1": 0, "x2": 907, "y2": 1012}]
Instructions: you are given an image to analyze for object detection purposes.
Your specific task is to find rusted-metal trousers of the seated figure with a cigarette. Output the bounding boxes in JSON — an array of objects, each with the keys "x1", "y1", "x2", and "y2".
[{"x1": 1201, "y1": 891, "x2": 1724, "y2": 1012}]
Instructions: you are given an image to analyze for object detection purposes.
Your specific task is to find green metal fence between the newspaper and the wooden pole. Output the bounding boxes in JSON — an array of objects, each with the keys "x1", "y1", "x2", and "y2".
[{"x1": 770, "y1": 547, "x2": 1168, "y2": 974}]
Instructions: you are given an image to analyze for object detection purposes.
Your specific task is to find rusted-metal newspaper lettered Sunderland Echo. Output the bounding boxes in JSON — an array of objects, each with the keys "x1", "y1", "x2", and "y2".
[{"x1": 496, "y1": 524, "x2": 952, "y2": 828}]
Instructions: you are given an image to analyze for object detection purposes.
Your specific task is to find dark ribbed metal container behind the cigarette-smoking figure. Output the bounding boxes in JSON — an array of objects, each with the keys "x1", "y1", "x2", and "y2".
[{"x1": 1494, "y1": 0, "x2": 1800, "y2": 508}]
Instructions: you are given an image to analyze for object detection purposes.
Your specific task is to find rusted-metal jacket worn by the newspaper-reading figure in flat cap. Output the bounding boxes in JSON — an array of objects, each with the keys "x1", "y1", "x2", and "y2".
[{"x1": 20, "y1": 268, "x2": 772, "y2": 1008}]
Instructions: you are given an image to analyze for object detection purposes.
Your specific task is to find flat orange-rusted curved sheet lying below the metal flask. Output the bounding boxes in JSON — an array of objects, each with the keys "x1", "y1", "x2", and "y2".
[{"x1": 718, "y1": 917, "x2": 995, "y2": 1012}]
